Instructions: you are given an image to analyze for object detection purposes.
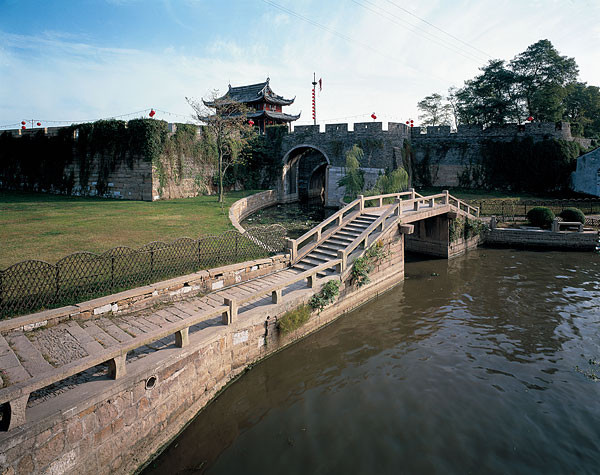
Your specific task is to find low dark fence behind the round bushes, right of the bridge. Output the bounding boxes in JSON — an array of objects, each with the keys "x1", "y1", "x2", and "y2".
[{"x1": 465, "y1": 199, "x2": 600, "y2": 217}]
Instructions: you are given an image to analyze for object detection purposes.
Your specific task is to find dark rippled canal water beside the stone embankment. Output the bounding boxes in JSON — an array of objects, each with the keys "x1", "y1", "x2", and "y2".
[{"x1": 148, "y1": 249, "x2": 600, "y2": 475}]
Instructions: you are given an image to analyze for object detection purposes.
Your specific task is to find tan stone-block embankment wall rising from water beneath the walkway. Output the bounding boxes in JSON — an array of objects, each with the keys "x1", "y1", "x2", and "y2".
[{"x1": 0, "y1": 228, "x2": 404, "y2": 475}]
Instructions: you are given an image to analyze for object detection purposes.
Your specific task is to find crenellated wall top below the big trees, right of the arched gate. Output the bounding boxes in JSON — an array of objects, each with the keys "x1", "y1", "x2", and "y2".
[{"x1": 411, "y1": 122, "x2": 573, "y2": 140}]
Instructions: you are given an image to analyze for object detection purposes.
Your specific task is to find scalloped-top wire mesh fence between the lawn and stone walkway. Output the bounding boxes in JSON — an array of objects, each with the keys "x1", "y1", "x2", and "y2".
[{"x1": 0, "y1": 224, "x2": 286, "y2": 317}]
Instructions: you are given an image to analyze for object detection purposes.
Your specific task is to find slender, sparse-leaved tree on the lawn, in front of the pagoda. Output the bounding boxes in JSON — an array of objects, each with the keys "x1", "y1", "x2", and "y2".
[{"x1": 185, "y1": 90, "x2": 255, "y2": 203}]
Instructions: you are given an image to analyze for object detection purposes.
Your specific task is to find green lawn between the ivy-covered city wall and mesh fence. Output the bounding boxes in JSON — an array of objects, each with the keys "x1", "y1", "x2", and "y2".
[{"x1": 0, "y1": 191, "x2": 255, "y2": 269}]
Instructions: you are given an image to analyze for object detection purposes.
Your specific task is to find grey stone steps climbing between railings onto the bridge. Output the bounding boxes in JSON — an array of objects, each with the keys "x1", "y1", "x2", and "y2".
[{"x1": 292, "y1": 213, "x2": 379, "y2": 278}]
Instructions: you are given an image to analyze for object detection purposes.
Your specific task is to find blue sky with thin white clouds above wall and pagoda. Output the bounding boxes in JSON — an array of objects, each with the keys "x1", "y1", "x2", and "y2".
[{"x1": 0, "y1": 0, "x2": 600, "y2": 126}]
